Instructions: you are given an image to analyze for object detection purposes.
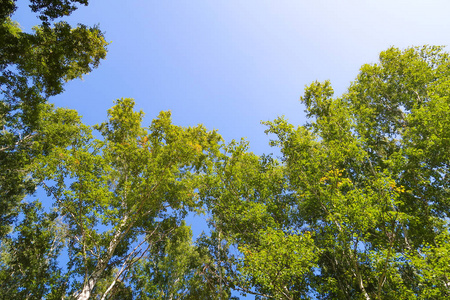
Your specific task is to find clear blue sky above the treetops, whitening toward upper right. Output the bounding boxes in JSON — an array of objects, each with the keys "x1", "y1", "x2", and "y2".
[{"x1": 15, "y1": 0, "x2": 450, "y2": 298}]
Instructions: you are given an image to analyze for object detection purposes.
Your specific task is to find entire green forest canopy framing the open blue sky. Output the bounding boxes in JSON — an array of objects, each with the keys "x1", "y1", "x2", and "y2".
[{"x1": 0, "y1": 0, "x2": 450, "y2": 300}]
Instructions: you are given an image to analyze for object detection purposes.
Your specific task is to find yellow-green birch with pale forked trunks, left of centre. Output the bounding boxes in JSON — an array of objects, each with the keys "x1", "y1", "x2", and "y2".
[{"x1": 33, "y1": 99, "x2": 220, "y2": 299}]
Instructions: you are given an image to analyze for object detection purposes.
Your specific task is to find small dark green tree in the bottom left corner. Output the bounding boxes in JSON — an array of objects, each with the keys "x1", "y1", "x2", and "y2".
[{"x1": 0, "y1": 201, "x2": 65, "y2": 299}]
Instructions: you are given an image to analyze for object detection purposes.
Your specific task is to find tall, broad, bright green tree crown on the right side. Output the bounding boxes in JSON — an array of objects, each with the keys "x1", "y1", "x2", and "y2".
[{"x1": 260, "y1": 47, "x2": 450, "y2": 299}]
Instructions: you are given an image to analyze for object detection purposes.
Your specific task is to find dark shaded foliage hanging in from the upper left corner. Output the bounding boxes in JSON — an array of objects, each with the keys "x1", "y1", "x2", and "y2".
[{"x1": 0, "y1": 1, "x2": 108, "y2": 237}]
